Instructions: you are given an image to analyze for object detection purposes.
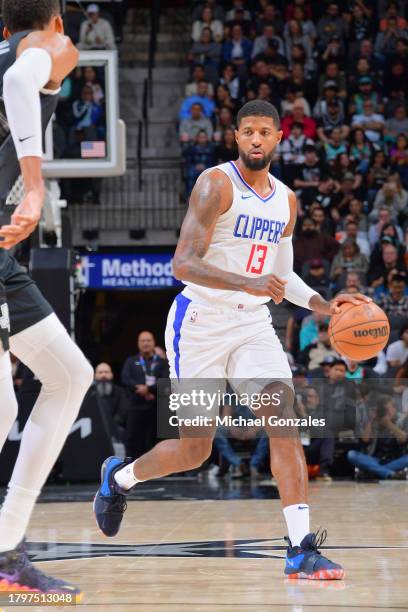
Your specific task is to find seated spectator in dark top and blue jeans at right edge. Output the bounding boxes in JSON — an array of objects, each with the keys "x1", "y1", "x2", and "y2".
[{"x1": 347, "y1": 397, "x2": 408, "y2": 480}]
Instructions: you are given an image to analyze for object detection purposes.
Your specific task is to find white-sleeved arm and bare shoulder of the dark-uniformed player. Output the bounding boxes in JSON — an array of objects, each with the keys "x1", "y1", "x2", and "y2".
[{"x1": 0, "y1": 32, "x2": 78, "y2": 248}]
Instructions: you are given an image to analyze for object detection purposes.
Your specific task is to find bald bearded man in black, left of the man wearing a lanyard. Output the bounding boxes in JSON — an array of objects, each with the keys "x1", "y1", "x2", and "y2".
[{"x1": 91, "y1": 363, "x2": 130, "y2": 442}]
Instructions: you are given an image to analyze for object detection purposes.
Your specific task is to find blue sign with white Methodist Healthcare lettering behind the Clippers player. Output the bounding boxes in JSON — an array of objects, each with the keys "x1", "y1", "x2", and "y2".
[{"x1": 79, "y1": 253, "x2": 181, "y2": 289}]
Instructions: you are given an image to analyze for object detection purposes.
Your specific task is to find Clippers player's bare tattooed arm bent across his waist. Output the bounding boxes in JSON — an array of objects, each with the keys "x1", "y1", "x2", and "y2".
[{"x1": 173, "y1": 169, "x2": 284, "y2": 301}]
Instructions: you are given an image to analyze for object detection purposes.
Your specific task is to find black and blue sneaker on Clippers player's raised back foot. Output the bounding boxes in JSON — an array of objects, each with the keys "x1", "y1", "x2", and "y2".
[{"x1": 93, "y1": 457, "x2": 133, "y2": 538}]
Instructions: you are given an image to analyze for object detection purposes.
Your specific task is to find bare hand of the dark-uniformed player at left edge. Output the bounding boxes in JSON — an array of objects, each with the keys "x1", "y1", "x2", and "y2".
[{"x1": 0, "y1": 190, "x2": 44, "y2": 249}]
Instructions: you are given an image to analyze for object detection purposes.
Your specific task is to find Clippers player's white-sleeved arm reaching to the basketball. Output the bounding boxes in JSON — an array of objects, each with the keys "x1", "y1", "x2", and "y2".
[{"x1": 275, "y1": 189, "x2": 371, "y2": 315}]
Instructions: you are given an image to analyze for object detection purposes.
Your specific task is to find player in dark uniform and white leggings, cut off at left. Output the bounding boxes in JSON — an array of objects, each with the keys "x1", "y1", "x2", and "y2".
[{"x1": 0, "y1": 0, "x2": 92, "y2": 595}]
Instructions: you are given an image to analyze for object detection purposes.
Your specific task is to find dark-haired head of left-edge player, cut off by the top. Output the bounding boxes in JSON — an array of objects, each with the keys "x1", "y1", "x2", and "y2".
[{"x1": 2, "y1": 0, "x2": 61, "y2": 34}]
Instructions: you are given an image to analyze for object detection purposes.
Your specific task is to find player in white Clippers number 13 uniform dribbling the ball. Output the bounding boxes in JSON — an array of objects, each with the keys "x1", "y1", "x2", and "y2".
[{"x1": 94, "y1": 100, "x2": 370, "y2": 580}]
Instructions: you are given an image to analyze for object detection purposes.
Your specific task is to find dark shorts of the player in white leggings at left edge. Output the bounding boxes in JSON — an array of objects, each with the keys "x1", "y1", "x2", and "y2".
[{"x1": 0, "y1": 249, "x2": 53, "y2": 336}]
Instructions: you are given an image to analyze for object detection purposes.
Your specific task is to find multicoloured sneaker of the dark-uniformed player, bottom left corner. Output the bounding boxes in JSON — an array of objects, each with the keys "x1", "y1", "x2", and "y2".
[{"x1": 0, "y1": 542, "x2": 83, "y2": 605}]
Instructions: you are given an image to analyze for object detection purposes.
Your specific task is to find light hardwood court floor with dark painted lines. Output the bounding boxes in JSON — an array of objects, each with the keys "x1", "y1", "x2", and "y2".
[{"x1": 19, "y1": 482, "x2": 408, "y2": 612}]
